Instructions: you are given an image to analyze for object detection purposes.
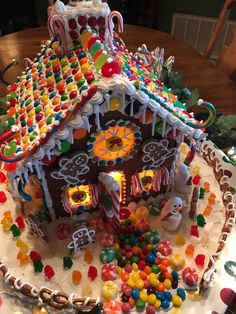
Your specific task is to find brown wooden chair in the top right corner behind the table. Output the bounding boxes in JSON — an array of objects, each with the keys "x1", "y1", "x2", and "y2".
[{"x1": 204, "y1": 0, "x2": 236, "y2": 81}]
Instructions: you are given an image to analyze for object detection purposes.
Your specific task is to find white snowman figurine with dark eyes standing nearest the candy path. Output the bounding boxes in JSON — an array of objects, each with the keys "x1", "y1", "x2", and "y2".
[{"x1": 161, "y1": 197, "x2": 183, "y2": 232}]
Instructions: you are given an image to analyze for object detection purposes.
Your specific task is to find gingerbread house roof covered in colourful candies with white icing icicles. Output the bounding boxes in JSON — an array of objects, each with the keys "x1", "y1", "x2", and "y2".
[{"x1": 0, "y1": 25, "x2": 212, "y2": 162}]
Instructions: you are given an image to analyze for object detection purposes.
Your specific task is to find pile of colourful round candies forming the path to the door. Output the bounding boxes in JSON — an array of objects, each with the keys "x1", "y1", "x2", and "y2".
[{"x1": 100, "y1": 220, "x2": 185, "y2": 314}]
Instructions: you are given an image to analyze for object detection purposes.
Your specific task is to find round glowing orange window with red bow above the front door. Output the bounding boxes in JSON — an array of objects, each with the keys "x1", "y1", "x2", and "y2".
[{"x1": 93, "y1": 125, "x2": 135, "y2": 160}]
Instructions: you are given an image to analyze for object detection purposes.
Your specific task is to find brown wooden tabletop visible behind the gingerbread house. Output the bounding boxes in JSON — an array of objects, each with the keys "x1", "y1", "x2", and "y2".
[{"x1": 0, "y1": 25, "x2": 236, "y2": 114}]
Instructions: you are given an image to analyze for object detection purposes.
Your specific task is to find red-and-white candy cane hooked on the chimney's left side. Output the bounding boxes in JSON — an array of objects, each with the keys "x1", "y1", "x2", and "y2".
[{"x1": 48, "y1": 15, "x2": 67, "y2": 53}]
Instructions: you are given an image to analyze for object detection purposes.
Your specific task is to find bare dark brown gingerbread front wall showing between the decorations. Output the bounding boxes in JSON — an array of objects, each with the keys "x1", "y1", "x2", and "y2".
[{"x1": 44, "y1": 111, "x2": 177, "y2": 217}]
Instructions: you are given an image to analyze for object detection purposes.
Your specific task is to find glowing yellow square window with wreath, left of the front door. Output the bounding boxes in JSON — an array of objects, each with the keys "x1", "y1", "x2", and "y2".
[{"x1": 68, "y1": 185, "x2": 92, "y2": 206}]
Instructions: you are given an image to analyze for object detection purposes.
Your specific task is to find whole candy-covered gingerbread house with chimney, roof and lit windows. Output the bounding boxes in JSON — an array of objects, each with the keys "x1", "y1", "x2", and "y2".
[{"x1": 0, "y1": 0, "x2": 214, "y2": 226}]
